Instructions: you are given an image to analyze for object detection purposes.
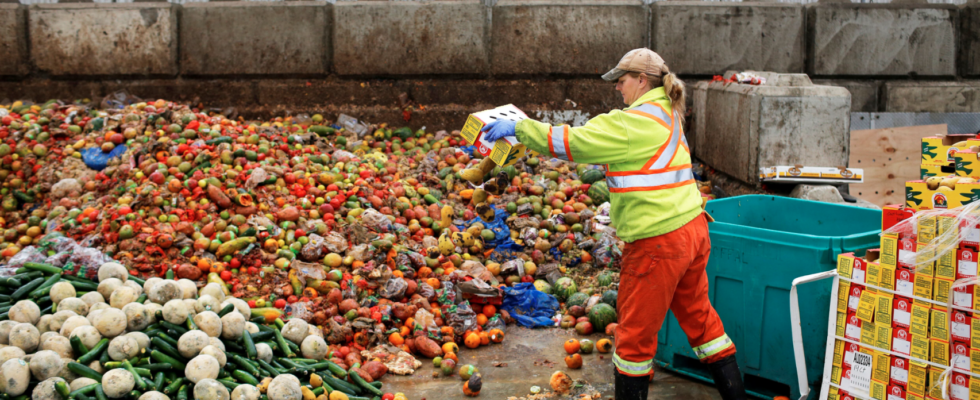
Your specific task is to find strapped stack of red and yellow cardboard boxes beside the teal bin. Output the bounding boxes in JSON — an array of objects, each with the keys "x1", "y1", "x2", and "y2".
[{"x1": 829, "y1": 206, "x2": 980, "y2": 400}]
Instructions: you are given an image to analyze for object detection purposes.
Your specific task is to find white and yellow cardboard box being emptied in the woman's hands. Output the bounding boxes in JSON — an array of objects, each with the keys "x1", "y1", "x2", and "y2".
[{"x1": 460, "y1": 104, "x2": 537, "y2": 166}]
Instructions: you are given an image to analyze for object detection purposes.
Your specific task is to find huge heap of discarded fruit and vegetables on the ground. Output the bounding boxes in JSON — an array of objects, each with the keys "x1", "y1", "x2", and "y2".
[{"x1": 0, "y1": 100, "x2": 708, "y2": 400}]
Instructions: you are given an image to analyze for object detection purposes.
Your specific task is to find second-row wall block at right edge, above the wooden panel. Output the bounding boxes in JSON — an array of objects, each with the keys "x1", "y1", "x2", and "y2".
[{"x1": 883, "y1": 81, "x2": 980, "y2": 113}]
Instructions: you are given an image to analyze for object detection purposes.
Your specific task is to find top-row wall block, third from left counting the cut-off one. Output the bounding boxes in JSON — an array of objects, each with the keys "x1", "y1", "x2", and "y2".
[{"x1": 180, "y1": 1, "x2": 333, "y2": 75}]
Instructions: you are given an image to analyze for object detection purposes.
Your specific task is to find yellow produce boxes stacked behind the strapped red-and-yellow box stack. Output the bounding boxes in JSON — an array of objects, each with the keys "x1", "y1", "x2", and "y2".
[{"x1": 905, "y1": 135, "x2": 980, "y2": 210}]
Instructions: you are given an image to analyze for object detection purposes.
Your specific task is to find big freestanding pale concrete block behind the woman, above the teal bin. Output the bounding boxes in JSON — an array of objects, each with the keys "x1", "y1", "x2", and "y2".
[{"x1": 692, "y1": 73, "x2": 851, "y2": 184}]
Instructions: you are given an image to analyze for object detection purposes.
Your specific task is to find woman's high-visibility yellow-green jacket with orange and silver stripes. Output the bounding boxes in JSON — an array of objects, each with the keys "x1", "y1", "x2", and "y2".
[{"x1": 515, "y1": 87, "x2": 701, "y2": 243}]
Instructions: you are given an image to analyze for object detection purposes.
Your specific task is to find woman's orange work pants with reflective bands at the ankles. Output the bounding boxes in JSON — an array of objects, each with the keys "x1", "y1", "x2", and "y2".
[{"x1": 613, "y1": 213, "x2": 735, "y2": 376}]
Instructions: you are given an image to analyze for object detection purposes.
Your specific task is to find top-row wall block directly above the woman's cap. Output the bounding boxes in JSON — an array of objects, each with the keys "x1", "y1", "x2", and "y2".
[{"x1": 490, "y1": 0, "x2": 648, "y2": 75}]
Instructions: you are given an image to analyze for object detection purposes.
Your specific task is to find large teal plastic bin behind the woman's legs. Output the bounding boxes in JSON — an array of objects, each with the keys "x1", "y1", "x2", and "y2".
[{"x1": 655, "y1": 195, "x2": 881, "y2": 399}]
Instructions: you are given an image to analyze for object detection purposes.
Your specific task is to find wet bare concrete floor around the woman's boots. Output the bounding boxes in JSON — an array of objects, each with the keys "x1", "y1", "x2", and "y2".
[{"x1": 383, "y1": 327, "x2": 721, "y2": 400}]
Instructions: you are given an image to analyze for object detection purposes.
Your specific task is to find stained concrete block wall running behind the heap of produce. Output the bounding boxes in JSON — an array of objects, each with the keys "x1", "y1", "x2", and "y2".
[{"x1": 0, "y1": 0, "x2": 980, "y2": 124}]
